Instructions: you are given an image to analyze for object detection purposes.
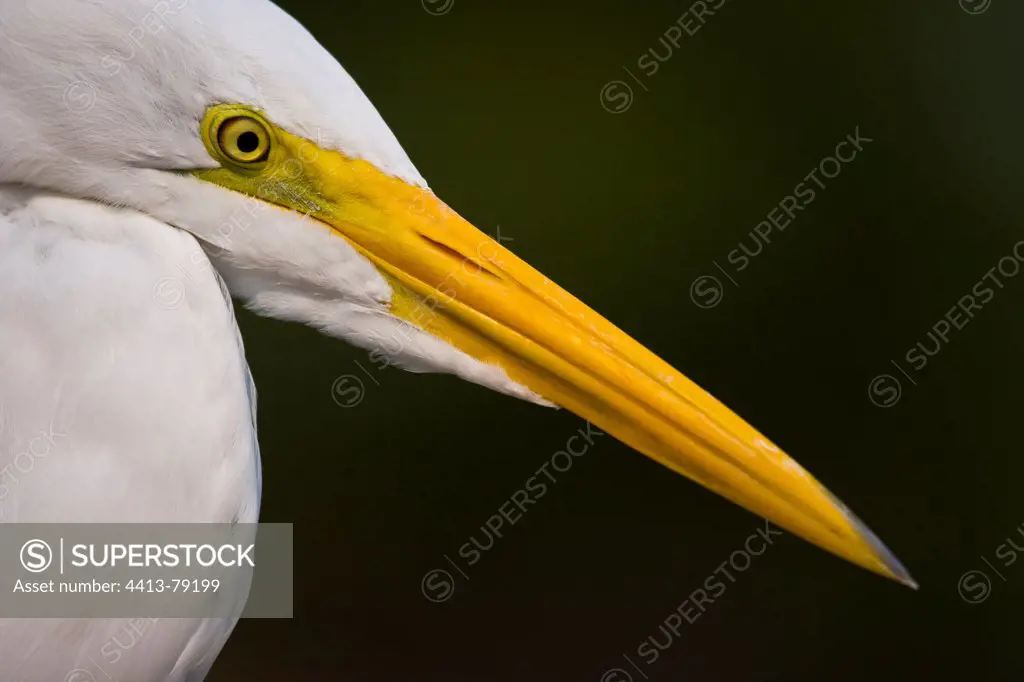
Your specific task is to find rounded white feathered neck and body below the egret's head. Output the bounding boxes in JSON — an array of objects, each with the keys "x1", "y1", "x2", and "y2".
[{"x1": 0, "y1": 189, "x2": 259, "y2": 682}]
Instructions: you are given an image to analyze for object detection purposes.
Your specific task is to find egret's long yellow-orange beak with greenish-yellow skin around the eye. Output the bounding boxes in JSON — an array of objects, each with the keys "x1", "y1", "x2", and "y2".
[{"x1": 196, "y1": 104, "x2": 915, "y2": 587}]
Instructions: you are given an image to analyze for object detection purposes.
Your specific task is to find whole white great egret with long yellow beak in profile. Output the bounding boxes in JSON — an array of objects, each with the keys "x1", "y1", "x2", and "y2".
[{"x1": 0, "y1": 0, "x2": 912, "y2": 682}]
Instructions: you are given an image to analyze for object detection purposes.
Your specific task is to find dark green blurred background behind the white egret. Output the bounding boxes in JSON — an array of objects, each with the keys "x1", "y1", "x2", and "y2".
[{"x1": 211, "y1": 0, "x2": 1024, "y2": 682}]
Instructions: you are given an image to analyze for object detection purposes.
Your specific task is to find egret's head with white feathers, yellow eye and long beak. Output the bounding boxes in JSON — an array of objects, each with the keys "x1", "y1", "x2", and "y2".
[{"x1": 0, "y1": 0, "x2": 910, "y2": 583}]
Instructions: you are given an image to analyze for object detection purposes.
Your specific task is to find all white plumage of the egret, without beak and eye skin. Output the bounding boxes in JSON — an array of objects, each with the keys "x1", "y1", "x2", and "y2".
[{"x1": 0, "y1": 0, "x2": 532, "y2": 682}]
